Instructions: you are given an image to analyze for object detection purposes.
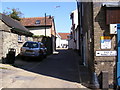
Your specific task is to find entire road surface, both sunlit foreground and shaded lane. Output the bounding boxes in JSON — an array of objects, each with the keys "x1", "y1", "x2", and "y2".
[{"x1": 0, "y1": 49, "x2": 90, "y2": 90}]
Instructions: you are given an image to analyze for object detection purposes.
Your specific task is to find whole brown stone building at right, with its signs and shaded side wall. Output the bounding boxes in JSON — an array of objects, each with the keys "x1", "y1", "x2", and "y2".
[{"x1": 77, "y1": 0, "x2": 120, "y2": 86}]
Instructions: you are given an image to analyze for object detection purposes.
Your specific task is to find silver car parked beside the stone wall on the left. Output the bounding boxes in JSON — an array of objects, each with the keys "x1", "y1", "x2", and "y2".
[{"x1": 20, "y1": 41, "x2": 47, "y2": 58}]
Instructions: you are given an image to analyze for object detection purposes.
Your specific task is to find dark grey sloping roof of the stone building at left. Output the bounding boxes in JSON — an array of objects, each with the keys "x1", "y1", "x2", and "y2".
[{"x1": 0, "y1": 14, "x2": 33, "y2": 36}]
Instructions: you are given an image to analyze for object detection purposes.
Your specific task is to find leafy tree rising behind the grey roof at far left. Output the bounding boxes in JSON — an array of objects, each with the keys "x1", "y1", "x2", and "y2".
[{"x1": 3, "y1": 8, "x2": 23, "y2": 21}]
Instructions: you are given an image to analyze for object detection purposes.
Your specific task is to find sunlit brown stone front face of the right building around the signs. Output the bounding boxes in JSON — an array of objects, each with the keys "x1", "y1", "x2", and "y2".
[{"x1": 93, "y1": 3, "x2": 116, "y2": 84}]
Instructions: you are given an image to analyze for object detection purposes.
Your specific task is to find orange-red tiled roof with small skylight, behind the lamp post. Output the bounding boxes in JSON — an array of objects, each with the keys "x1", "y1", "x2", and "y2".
[{"x1": 20, "y1": 17, "x2": 53, "y2": 26}]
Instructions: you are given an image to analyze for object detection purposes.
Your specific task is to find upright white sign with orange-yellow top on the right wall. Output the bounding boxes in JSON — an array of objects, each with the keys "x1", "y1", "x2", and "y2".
[{"x1": 100, "y1": 36, "x2": 111, "y2": 49}]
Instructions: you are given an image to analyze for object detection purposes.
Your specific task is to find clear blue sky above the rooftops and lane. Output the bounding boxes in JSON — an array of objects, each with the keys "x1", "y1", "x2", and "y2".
[{"x1": 2, "y1": 2, "x2": 76, "y2": 33}]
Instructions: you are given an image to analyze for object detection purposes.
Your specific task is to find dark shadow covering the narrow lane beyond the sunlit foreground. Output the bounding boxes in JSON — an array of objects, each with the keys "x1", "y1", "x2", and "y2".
[{"x1": 15, "y1": 50, "x2": 80, "y2": 83}]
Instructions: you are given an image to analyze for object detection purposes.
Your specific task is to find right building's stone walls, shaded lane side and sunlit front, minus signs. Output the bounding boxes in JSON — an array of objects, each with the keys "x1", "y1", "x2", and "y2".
[{"x1": 80, "y1": 2, "x2": 116, "y2": 85}]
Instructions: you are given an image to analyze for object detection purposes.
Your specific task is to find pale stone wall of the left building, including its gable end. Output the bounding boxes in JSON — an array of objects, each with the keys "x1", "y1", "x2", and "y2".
[{"x1": 0, "y1": 19, "x2": 33, "y2": 59}]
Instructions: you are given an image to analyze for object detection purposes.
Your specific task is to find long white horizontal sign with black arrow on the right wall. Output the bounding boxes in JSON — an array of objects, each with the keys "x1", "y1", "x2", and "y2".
[{"x1": 96, "y1": 51, "x2": 117, "y2": 56}]
